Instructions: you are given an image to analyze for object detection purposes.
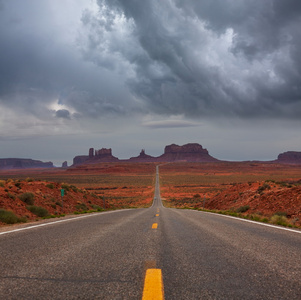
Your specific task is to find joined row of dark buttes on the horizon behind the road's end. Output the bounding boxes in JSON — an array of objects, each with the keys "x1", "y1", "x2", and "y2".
[{"x1": 73, "y1": 143, "x2": 219, "y2": 166}]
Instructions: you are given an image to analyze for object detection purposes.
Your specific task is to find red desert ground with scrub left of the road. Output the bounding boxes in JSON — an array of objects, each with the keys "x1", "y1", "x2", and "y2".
[{"x1": 0, "y1": 163, "x2": 155, "y2": 225}]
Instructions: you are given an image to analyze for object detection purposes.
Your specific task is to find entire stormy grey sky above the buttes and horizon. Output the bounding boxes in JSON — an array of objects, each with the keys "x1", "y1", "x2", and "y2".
[{"x1": 0, "y1": 0, "x2": 301, "y2": 166}]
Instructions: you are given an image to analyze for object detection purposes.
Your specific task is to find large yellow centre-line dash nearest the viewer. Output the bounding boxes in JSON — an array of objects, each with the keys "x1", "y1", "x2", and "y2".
[{"x1": 142, "y1": 269, "x2": 164, "y2": 300}]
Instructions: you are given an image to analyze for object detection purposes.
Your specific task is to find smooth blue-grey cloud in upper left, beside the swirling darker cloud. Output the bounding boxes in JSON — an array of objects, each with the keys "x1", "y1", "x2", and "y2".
[{"x1": 0, "y1": 0, "x2": 135, "y2": 123}]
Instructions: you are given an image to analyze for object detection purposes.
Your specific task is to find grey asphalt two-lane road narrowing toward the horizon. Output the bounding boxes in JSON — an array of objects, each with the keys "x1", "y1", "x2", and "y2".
[{"x1": 0, "y1": 165, "x2": 301, "y2": 299}]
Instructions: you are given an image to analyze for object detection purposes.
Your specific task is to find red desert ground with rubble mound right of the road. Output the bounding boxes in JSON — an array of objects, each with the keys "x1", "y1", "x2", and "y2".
[{"x1": 160, "y1": 162, "x2": 301, "y2": 226}]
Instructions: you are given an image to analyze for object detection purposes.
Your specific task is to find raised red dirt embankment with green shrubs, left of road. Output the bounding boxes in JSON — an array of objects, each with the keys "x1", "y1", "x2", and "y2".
[{"x1": 0, "y1": 179, "x2": 108, "y2": 225}]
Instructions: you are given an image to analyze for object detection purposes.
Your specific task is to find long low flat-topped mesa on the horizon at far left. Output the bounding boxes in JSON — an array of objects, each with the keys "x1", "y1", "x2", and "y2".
[{"x1": 0, "y1": 158, "x2": 54, "y2": 170}]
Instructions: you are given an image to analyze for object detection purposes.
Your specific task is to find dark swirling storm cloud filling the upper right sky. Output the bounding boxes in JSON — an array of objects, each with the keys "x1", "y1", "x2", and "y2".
[{"x1": 78, "y1": 0, "x2": 301, "y2": 118}]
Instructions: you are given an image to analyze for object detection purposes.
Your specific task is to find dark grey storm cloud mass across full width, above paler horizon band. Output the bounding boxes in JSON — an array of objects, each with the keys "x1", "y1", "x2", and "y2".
[{"x1": 0, "y1": 0, "x2": 301, "y2": 125}]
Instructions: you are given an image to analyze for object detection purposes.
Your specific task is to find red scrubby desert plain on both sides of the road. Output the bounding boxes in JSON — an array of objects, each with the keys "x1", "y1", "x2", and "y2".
[{"x1": 0, "y1": 158, "x2": 301, "y2": 227}]
